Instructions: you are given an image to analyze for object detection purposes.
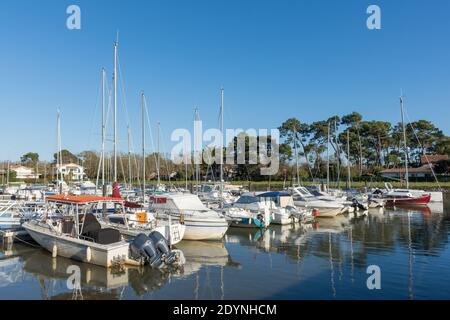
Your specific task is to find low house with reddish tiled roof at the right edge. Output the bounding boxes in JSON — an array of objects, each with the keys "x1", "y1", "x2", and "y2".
[{"x1": 380, "y1": 154, "x2": 450, "y2": 179}]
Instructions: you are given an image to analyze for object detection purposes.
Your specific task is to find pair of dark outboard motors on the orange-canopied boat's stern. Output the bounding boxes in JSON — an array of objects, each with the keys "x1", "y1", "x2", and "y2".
[{"x1": 130, "y1": 231, "x2": 179, "y2": 268}]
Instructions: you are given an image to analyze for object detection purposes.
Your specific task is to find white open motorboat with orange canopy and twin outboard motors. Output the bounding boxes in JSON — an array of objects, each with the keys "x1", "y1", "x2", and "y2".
[{"x1": 22, "y1": 195, "x2": 184, "y2": 268}]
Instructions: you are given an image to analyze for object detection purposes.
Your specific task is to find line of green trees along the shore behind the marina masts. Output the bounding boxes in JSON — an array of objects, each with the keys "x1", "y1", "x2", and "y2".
[{"x1": 3, "y1": 112, "x2": 450, "y2": 183}]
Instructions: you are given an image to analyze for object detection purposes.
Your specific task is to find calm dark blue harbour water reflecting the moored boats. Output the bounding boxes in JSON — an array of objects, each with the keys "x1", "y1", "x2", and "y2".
[{"x1": 0, "y1": 199, "x2": 450, "y2": 299}]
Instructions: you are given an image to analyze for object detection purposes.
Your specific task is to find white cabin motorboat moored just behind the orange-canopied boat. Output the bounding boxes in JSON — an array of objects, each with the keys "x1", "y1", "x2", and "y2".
[{"x1": 149, "y1": 193, "x2": 229, "y2": 240}]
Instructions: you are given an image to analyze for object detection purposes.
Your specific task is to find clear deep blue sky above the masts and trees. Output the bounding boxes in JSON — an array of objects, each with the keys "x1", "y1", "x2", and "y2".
[{"x1": 0, "y1": 0, "x2": 450, "y2": 161}]
